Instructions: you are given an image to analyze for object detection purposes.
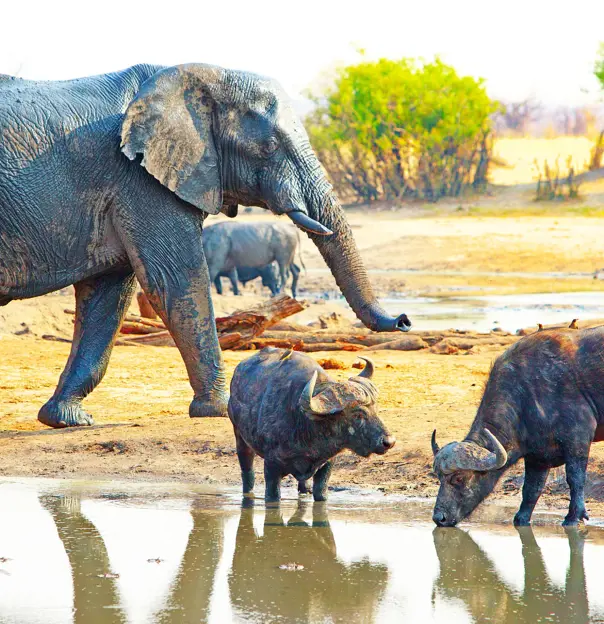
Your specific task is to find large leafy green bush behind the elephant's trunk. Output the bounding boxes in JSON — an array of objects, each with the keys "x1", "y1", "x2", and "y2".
[{"x1": 305, "y1": 59, "x2": 498, "y2": 201}]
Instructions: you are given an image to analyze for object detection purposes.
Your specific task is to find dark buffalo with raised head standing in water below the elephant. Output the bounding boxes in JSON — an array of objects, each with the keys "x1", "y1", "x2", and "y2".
[{"x1": 229, "y1": 347, "x2": 395, "y2": 501}]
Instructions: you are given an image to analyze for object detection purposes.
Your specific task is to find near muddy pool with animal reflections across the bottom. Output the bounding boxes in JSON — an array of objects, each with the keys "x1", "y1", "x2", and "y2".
[{"x1": 0, "y1": 480, "x2": 604, "y2": 624}]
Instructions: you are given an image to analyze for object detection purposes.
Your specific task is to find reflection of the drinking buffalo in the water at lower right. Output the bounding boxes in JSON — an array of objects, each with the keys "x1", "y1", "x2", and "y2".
[{"x1": 433, "y1": 527, "x2": 590, "y2": 624}]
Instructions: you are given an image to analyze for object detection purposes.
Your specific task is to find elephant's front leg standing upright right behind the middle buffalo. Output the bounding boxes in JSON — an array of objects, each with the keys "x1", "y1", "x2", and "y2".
[{"x1": 118, "y1": 207, "x2": 228, "y2": 417}]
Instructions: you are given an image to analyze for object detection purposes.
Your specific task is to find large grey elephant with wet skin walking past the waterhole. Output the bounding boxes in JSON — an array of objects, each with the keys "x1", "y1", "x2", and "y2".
[{"x1": 0, "y1": 63, "x2": 411, "y2": 427}]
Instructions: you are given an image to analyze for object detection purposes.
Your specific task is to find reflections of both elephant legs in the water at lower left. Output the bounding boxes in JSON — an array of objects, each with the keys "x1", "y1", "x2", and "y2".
[{"x1": 40, "y1": 496, "x2": 223, "y2": 624}]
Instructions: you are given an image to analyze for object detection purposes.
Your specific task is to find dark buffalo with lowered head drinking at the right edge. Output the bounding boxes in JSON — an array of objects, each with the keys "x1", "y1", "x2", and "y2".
[{"x1": 432, "y1": 327, "x2": 604, "y2": 526}]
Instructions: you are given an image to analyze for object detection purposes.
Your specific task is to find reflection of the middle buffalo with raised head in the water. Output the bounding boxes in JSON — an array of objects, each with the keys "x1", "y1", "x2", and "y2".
[{"x1": 229, "y1": 502, "x2": 388, "y2": 622}]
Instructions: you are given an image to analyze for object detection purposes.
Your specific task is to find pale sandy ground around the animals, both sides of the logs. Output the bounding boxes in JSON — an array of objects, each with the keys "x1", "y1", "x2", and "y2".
[{"x1": 0, "y1": 207, "x2": 604, "y2": 516}]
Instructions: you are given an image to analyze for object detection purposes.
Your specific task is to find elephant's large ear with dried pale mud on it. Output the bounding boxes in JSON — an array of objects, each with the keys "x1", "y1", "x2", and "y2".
[{"x1": 121, "y1": 65, "x2": 224, "y2": 214}]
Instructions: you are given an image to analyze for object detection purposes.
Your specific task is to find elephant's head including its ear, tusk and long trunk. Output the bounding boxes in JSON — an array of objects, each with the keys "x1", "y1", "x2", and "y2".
[{"x1": 122, "y1": 64, "x2": 411, "y2": 331}]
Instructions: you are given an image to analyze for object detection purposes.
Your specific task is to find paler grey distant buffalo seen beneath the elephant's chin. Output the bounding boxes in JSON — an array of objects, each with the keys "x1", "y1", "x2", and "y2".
[{"x1": 203, "y1": 221, "x2": 300, "y2": 297}]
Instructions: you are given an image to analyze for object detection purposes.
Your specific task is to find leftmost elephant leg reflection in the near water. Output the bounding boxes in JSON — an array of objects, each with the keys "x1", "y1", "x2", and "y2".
[{"x1": 40, "y1": 495, "x2": 126, "y2": 624}]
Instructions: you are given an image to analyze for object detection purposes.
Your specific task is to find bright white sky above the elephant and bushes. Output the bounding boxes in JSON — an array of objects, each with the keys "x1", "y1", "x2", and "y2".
[{"x1": 0, "y1": 0, "x2": 604, "y2": 105}]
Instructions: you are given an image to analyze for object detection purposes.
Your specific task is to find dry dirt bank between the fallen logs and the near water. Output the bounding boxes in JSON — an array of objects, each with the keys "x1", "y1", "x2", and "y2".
[{"x1": 0, "y1": 337, "x2": 604, "y2": 515}]
